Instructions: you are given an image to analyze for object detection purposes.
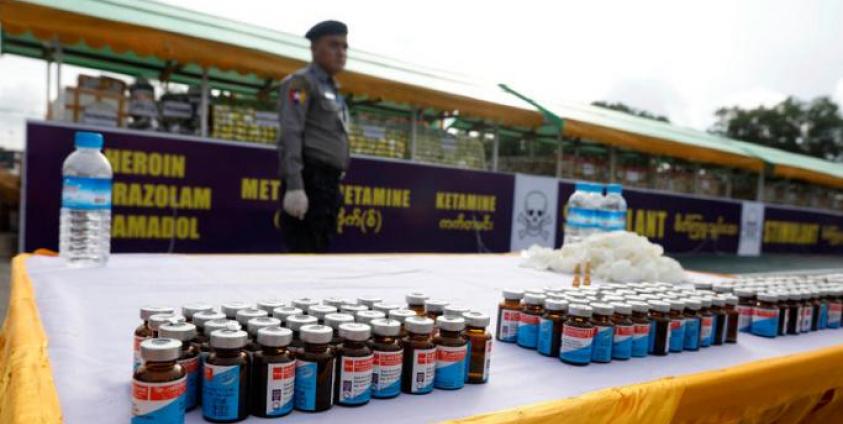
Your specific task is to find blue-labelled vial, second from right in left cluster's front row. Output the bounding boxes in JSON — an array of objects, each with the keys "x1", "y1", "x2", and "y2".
[{"x1": 433, "y1": 316, "x2": 468, "y2": 390}]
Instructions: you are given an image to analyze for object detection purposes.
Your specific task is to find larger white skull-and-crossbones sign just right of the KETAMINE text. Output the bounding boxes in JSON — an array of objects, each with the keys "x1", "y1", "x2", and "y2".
[{"x1": 510, "y1": 174, "x2": 559, "y2": 251}]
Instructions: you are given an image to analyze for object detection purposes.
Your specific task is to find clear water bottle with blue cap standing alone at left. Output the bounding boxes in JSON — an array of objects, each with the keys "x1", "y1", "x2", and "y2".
[{"x1": 59, "y1": 132, "x2": 113, "y2": 266}]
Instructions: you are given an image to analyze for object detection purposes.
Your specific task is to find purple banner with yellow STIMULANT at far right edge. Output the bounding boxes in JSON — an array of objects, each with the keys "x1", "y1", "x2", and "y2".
[{"x1": 761, "y1": 206, "x2": 843, "y2": 254}]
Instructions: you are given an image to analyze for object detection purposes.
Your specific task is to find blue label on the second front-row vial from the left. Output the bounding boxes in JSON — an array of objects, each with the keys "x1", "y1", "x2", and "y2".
[{"x1": 202, "y1": 363, "x2": 240, "y2": 420}]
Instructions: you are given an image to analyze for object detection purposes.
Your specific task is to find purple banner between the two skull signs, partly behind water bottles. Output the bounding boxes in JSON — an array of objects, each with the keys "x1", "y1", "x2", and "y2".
[{"x1": 556, "y1": 181, "x2": 741, "y2": 253}]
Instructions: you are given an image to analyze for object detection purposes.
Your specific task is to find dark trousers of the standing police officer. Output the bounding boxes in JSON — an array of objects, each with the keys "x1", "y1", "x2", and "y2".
[{"x1": 281, "y1": 162, "x2": 342, "y2": 253}]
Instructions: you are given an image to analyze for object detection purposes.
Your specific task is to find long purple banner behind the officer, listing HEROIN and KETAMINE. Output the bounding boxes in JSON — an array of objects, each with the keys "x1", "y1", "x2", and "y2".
[{"x1": 22, "y1": 122, "x2": 514, "y2": 253}]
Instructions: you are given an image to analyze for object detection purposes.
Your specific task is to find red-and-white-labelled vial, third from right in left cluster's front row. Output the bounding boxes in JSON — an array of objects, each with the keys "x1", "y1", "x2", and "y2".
[{"x1": 401, "y1": 316, "x2": 436, "y2": 395}]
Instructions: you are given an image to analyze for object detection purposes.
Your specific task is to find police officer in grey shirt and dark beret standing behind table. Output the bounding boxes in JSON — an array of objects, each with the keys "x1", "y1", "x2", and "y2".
[{"x1": 278, "y1": 21, "x2": 349, "y2": 252}]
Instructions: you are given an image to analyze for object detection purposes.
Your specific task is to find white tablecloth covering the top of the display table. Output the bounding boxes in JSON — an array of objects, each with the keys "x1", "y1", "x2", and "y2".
[{"x1": 27, "y1": 255, "x2": 843, "y2": 423}]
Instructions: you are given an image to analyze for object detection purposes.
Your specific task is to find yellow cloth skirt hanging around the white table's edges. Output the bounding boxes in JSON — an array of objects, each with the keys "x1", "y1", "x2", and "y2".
[{"x1": 0, "y1": 255, "x2": 843, "y2": 424}]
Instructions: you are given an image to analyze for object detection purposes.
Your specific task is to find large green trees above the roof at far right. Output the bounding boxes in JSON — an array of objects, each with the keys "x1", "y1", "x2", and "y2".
[{"x1": 710, "y1": 96, "x2": 843, "y2": 161}]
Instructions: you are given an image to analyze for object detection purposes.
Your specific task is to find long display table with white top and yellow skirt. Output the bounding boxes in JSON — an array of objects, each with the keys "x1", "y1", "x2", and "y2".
[{"x1": 0, "y1": 255, "x2": 843, "y2": 423}]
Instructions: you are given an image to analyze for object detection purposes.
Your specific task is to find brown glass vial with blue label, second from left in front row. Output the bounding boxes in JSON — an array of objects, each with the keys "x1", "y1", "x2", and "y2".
[{"x1": 202, "y1": 323, "x2": 251, "y2": 423}]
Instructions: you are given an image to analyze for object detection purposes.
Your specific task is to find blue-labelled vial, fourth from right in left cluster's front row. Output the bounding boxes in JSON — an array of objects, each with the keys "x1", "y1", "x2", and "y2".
[{"x1": 369, "y1": 318, "x2": 404, "y2": 399}]
